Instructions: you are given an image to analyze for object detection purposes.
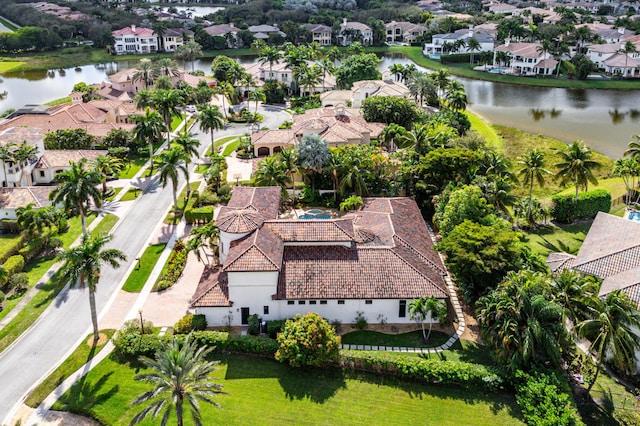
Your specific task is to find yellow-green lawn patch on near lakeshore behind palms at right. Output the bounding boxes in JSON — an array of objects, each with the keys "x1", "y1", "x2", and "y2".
[{"x1": 493, "y1": 126, "x2": 614, "y2": 198}]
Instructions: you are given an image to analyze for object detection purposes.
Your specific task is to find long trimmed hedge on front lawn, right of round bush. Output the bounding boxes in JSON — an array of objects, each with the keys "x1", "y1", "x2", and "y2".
[{"x1": 340, "y1": 351, "x2": 505, "y2": 392}]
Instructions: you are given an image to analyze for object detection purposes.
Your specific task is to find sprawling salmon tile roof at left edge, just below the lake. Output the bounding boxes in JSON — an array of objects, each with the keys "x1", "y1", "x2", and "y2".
[{"x1": 0, "y1": 103, "x2": 133, "y2": 138}]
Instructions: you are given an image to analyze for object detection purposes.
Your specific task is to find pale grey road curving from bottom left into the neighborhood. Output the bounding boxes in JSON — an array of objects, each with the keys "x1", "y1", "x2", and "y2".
[{"x1": 0, "y1": 106, "x2": 289, "y2": 424}]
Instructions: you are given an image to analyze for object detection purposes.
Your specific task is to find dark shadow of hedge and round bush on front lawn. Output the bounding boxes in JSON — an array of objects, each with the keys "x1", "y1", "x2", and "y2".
[{"x1": 221, "y1": 355, "x2": 346, "y2": 404}]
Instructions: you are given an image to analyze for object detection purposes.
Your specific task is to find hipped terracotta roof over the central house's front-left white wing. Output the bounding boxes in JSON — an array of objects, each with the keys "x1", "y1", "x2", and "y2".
[{"x1": 223, "y1": 227, "x2": 284, "y2": 272}]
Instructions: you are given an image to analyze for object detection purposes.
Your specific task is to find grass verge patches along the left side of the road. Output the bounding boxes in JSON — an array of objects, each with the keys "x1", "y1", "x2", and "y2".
[{"x1": 0, "y1": 214, "x2": 117, "y2": 352}]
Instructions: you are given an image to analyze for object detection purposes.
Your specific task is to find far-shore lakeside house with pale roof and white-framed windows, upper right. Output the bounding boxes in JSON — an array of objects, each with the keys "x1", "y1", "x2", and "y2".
[{"x1": 493, "y1": 40, "x2": 558, "y2": 76}]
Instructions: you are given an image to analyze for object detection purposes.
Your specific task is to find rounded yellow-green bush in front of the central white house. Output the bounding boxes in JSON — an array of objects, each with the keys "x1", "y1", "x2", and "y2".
[{"x1": 275, "y1": 312, "x2": 340, "y2": 367}]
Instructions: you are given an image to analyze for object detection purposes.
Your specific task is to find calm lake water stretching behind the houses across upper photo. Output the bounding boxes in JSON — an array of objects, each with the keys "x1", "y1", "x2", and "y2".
[{"x1": 0, "y1": 55, "x2": 640, "y2": 158}]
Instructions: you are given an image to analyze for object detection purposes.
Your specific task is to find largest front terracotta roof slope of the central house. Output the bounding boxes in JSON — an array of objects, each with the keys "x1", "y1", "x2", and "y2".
[{"x1": 276, "y1": 246, "x2": 447, "y2": 299}]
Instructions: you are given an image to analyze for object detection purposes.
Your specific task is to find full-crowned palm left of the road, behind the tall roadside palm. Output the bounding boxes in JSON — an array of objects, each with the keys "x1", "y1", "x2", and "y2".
[{"x1": 49, "y1": 158, "x2": 102, "y2": 234}]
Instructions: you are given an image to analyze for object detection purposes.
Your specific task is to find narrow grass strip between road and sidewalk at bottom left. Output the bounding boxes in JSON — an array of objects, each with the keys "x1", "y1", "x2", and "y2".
[{"x1": 25, "y1": 330, "x2": 115, "y2": 408}]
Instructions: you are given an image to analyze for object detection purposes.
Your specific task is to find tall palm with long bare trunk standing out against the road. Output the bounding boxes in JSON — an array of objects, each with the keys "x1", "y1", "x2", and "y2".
[{"x1": 58, "y1": 235, "x2": 127, "y2": 342}]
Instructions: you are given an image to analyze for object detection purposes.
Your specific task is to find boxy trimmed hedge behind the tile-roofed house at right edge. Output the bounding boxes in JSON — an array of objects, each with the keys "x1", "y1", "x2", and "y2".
[{"x1": 551, "y1": 189, "x2": 611, "y2": 223}]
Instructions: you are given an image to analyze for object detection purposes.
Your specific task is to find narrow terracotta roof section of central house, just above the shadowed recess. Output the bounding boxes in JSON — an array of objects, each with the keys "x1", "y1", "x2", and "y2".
[{"x1": 265, "y1": 219, "x2": 356, "y2": 242}]
